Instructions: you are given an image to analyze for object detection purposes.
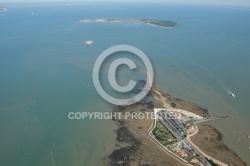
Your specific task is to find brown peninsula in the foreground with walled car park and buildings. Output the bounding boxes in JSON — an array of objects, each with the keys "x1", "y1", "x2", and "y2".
[{"x1": 101, "y1": 81, "x2": 246, "y2": 166}]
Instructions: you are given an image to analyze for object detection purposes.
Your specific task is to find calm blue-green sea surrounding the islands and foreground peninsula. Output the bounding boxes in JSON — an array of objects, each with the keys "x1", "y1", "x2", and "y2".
[{"x1": 0, "y1": 3, "x2": 250, "y2": 166}]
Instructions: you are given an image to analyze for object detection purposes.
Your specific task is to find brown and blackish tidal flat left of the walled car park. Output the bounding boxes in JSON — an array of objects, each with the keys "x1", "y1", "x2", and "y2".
[{"x1": 101, "y1": 103, "x2": 186, "y2": 166}]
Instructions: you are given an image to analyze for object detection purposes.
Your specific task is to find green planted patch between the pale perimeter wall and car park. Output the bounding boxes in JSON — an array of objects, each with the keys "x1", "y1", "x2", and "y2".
[{"x1": 153, "y1": 121, "x2": 176, "y2": 146}]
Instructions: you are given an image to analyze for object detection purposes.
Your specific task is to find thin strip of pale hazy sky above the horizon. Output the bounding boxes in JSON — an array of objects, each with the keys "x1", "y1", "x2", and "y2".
[{"x1": 0, "y1": 0, "x2": 250, "y2": 7}]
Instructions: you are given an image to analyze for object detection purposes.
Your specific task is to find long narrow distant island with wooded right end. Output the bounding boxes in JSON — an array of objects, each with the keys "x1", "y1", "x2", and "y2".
[{"x1": 80, "y1": 18, "x2": 177, "y2": 28}]
